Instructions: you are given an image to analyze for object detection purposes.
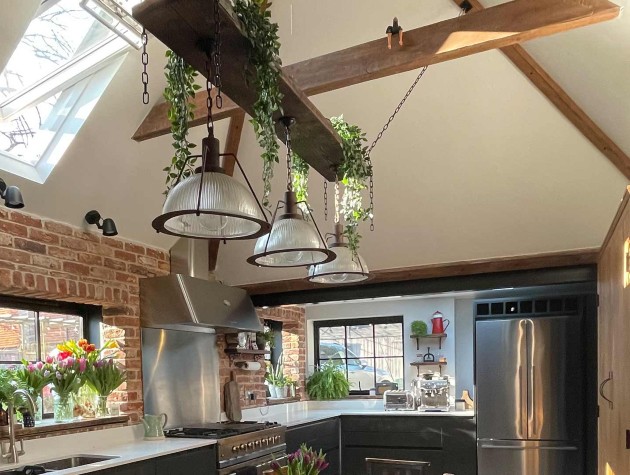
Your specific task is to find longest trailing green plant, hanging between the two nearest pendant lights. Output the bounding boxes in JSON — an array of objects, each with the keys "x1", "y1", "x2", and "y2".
[{"x1": 233, "y1": 0, "x2": 282, "y2": 208}]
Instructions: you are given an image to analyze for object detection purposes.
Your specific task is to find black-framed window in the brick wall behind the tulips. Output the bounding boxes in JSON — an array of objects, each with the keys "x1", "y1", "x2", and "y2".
[{"x1": 0, "y1": 297, "x2": 100, "y2": 414}]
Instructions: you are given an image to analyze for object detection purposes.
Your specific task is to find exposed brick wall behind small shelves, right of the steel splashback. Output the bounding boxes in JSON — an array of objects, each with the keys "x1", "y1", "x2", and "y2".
[{"x1": 217, "y1": 307, "x2": 306, "y2": 408}]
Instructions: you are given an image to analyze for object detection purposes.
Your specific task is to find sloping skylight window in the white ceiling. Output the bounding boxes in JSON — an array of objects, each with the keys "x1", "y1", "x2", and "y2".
[{"x1": 0, "y1": 0, "x2": 137, "y2": 183}]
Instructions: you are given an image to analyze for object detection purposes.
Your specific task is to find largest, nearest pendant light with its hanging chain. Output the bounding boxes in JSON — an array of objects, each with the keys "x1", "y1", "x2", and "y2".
[{"x1": 152, "y1": 35, "x2": 271, "y2": 240}]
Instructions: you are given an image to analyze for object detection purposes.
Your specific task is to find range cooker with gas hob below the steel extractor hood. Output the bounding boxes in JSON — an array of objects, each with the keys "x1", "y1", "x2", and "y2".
[{"x1": 164, "y1": 421, "x2": 286, "y2": 475}]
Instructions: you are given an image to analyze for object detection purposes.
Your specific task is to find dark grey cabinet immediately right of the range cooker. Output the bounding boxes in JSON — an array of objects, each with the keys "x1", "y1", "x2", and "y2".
[{"x1": 286, "y1": 417, "x2": 341, "y2": 475}]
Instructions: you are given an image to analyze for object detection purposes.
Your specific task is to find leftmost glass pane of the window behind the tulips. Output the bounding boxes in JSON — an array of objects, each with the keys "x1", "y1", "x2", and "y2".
[{"x1": 0, "y1": 307, "x2": 37, "y2": 361}]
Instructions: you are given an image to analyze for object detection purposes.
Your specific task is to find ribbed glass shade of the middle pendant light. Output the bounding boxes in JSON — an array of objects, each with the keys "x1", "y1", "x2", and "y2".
[{"x1": 247, "y1": 216, "x2": 335, "y2": 267}]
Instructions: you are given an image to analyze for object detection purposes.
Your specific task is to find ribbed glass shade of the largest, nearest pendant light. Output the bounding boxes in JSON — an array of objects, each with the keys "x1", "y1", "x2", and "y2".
[{"x1": 153, "y1": 172, "x2": 270, "y2": 239}]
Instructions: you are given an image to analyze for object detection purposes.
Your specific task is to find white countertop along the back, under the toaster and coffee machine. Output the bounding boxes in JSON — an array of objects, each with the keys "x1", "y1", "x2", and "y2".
[{"x1": 243, "y1": 400, "x2": 475, "y2": 427}]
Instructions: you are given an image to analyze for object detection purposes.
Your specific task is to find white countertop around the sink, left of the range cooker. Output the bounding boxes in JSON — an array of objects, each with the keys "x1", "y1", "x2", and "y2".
[{"x1": 0, "y1": 425, "x2": 217, "y2": 475}]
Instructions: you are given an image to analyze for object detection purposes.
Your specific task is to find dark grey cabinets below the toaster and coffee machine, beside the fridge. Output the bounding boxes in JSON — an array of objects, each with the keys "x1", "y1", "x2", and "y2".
[{"x1": 341, "y1": 415, "x2": 477, "y2": 475}]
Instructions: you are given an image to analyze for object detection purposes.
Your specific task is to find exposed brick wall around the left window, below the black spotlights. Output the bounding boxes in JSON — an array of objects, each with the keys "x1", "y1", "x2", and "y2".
[{"x1": 0, "y1": 208, "x2": 170, "y2": 422}]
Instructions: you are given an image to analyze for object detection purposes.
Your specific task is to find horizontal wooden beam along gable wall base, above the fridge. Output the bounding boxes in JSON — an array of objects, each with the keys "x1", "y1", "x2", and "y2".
[{"x1": 239, "y1": 248, "x2": 599, "y2": 295}]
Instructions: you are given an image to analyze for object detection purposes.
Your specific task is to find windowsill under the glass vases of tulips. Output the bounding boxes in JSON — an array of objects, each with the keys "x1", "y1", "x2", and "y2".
[{"x1": 0, "y1": 415, "x2": 129, "y2": 439}]
